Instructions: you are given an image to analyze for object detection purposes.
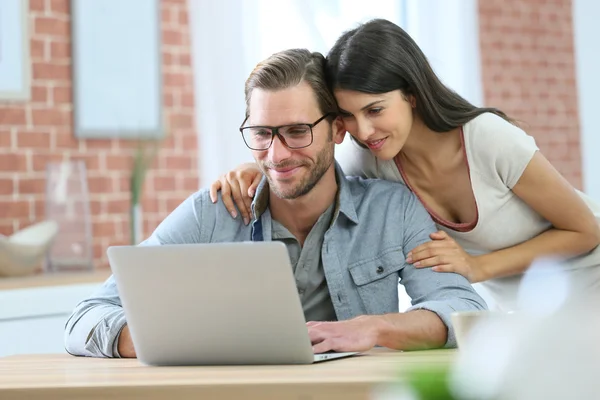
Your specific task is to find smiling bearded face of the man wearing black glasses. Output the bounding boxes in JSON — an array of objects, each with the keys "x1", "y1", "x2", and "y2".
[{"x1": 245, "y1": 82, "x2": 344, "y2": 199}]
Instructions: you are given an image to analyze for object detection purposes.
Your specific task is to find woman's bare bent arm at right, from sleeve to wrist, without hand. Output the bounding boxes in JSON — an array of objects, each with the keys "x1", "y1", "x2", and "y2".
[{"x1": 476, "y1": 152, "x2": 600, "y2": 280}]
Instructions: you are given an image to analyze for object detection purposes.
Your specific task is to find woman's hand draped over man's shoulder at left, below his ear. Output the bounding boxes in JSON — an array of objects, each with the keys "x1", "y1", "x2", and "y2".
[{"x1": 210, "y1": 163, "x2": 262, "y2": 225}]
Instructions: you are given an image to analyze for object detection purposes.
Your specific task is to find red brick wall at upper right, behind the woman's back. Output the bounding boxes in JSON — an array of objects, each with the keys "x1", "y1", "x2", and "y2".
[{"x1": 479, "y1": 0, "x2": 582, "y2": 188}]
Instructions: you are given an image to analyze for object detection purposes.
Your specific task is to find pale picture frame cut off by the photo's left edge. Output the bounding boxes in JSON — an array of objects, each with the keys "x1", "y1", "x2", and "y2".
[{"x1": 0, "y1": 0, "x2": 31, "y2": 101}]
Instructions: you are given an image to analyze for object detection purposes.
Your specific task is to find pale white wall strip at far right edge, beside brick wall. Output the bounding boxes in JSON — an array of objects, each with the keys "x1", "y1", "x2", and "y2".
[{"x1": 573, "y1": 0, "x2": 600, "y2": 201}]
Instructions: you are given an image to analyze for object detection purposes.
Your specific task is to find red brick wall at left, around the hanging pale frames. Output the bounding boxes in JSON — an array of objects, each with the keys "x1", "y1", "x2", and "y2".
[{"x1": 0, "y1": 0, "x2": 198, "y2": 266}]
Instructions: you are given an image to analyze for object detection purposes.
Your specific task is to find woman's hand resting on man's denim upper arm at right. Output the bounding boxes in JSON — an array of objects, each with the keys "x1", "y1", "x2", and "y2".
[{"x1": 406, "y1": 231, "x2": 485, "y2": 283}]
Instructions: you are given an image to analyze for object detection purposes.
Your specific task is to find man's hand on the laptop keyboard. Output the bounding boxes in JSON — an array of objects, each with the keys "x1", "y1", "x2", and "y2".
[{"x1": 306, "y1": 315, "x2": 381, "y2": 354}]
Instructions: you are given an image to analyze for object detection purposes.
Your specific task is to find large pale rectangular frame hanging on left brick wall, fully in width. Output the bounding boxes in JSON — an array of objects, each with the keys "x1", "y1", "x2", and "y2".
[{"x1": 71, "y1": 0, "x2": 165, "y2": 140}]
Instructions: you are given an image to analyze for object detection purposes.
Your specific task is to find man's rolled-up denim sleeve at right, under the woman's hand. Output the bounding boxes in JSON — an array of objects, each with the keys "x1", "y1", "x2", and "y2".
[{"x1": 400, "y1": 192, "x2": 487, "y2": 348}]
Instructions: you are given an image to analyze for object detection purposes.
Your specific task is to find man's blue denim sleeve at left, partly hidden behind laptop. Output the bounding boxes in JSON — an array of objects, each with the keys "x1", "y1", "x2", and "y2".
[{"x1": 64, "y1": 193, "x2": 206, "y2": 357}]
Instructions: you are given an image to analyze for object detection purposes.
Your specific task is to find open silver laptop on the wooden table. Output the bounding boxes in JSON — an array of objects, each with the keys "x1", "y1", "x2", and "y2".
[{"x1": 107, "y1": 242, "x2": 357, "y2": 365}]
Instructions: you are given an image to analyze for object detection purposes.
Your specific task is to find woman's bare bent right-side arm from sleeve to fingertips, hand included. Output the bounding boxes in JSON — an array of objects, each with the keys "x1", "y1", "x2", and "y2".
[{"x1": 407, "y1": 152, "x2": 600, "y2": 283}]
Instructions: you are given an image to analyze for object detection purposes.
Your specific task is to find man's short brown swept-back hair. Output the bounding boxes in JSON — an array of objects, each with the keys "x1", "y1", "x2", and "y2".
[{"x1": 245, "y1": 49, "x2": 337, "y2": 120}]
